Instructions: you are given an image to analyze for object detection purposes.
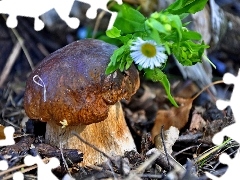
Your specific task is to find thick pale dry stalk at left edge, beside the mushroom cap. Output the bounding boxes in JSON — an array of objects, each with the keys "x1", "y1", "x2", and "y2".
[{"x1": 0, "y1": 42, "x2": 21, "y2": 87}]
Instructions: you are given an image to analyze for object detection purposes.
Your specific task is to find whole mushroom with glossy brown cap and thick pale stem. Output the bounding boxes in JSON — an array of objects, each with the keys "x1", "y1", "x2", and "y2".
[{"x1": 24, "y1": 39, "x2": 140, "y2": 165}]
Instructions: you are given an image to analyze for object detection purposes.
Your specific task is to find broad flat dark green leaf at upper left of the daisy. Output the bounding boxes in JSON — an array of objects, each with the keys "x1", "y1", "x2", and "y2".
[{"x1": 114, "y1": 4, "x2": 146, "y2": 34}]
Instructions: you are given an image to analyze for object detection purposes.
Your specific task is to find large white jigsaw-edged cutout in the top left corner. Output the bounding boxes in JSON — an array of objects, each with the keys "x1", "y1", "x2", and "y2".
[{"x1": 0, "y1": 0, "x2": 80, "y2": 31}]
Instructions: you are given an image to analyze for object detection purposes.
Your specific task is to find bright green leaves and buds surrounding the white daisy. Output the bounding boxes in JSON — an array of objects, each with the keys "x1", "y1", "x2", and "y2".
[{"x1": 103, "y1": 0, "x2": 212, "y2": 106}]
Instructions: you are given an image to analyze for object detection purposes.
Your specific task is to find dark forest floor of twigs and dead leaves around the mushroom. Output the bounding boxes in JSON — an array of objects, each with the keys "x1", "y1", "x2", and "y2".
[{"x1": 0, "y1": 1, "x2": 240, "y2": 180}]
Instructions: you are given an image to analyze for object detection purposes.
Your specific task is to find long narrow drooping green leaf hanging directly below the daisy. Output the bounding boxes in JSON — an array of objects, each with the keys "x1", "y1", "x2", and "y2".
[{"x1": 144, "y1": 68, "x2": 178, "y2": 107}]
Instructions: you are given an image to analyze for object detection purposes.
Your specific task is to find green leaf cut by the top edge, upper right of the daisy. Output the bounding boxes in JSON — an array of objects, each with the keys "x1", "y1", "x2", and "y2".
[{"x1": 165, "y1": 0, "x2": 208, "y2": 15}]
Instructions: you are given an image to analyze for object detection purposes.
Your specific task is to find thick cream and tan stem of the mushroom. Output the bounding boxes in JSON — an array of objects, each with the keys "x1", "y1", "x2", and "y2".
[{"x1": 45, "y1": 102, "x2": 136, "y2": 166}]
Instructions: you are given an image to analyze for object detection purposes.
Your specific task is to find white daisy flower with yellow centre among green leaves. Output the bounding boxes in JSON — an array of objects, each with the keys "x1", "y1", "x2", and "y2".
[{"x1": 130, "y1": 37, "x2": 167, "y2": 69}]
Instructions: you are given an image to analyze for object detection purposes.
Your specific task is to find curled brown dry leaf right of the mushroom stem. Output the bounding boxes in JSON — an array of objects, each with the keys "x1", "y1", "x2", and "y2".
[{"x1": 152, "y1": 98, "x2": 193, "y2": 139}]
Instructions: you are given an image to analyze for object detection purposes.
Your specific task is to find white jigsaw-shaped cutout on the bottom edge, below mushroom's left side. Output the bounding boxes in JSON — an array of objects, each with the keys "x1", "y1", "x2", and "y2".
[{"x1": 24, "y1": 155, "x2": 60, "y2": 180}]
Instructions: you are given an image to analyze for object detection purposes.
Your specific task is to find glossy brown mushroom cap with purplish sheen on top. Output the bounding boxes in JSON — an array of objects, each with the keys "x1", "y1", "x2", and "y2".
[{"x1": 24, "y1": 39, "x2": 139, "y2": 125}]
